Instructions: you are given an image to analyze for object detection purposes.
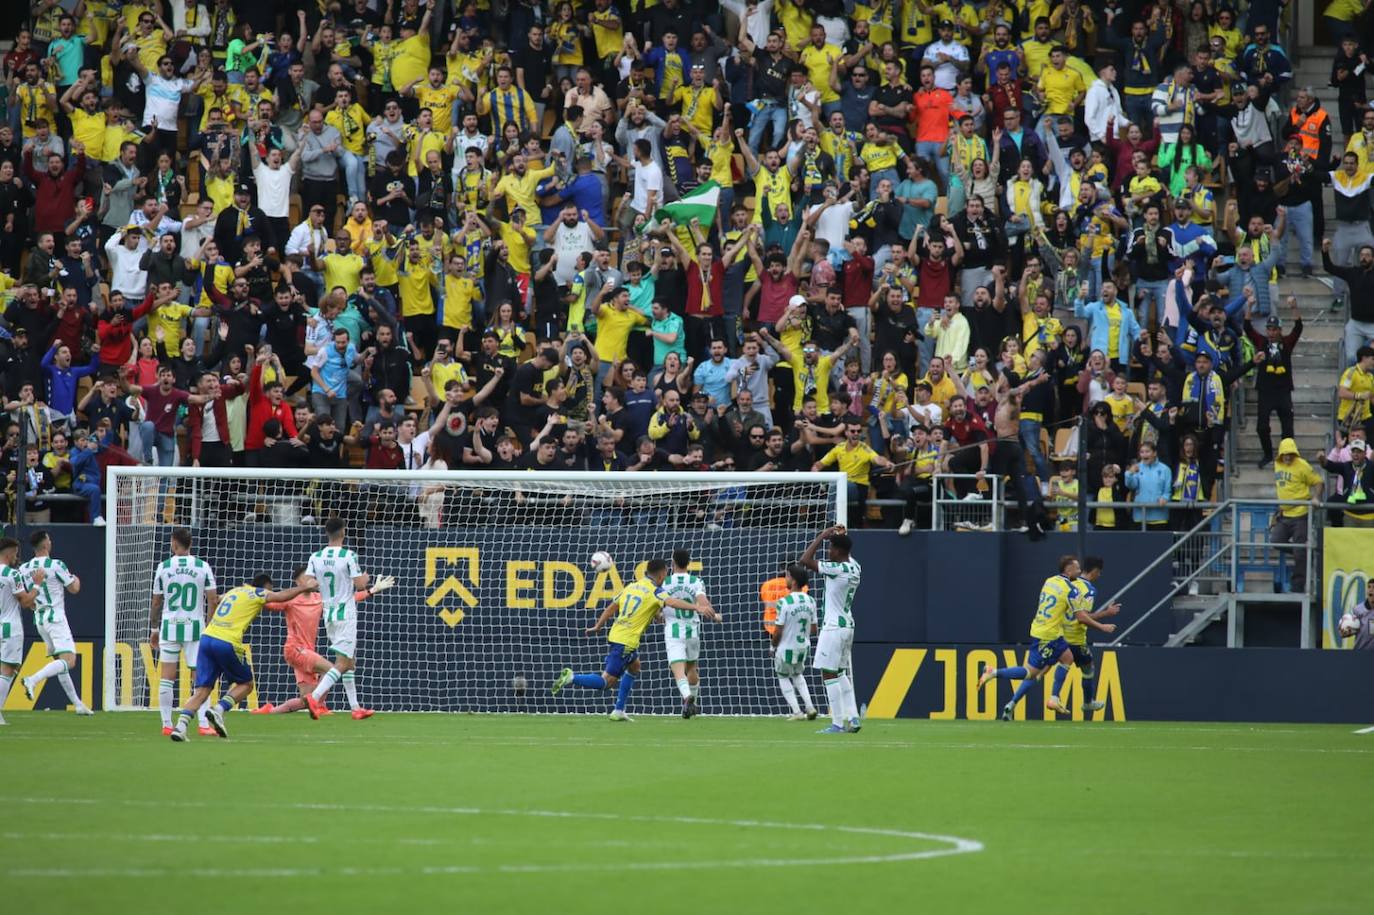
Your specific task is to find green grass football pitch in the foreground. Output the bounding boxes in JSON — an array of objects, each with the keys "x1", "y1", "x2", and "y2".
[{"x1": 0, "y1": 713, "x2": 1374, "y2": 915}]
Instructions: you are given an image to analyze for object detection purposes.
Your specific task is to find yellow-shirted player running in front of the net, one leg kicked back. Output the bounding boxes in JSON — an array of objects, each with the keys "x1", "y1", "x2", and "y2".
[{"x1": 554, "y1": 559, "x2": 698, "y2": 721}]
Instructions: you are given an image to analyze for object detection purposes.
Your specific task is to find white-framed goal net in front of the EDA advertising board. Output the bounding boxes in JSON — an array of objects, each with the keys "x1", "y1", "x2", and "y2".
[{"x1": 104, "y1": 467, "x2": 846, "y2": 714}]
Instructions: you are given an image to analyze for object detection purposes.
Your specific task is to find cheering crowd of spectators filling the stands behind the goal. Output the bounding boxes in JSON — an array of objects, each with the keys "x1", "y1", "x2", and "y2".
[{"x1": 0, "y1": 0, "x2": 1352, "y2": 532}]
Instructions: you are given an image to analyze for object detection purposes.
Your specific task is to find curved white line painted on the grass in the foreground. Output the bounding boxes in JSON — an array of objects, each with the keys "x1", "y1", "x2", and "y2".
[{"x1": 0, "y1": 797, "x2": 984, "y2": 879}]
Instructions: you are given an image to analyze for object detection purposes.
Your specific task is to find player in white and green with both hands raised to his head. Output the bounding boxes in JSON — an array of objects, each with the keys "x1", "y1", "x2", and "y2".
[{"x1": 800, "y1": 525, "x2": 861, "y2": 734}]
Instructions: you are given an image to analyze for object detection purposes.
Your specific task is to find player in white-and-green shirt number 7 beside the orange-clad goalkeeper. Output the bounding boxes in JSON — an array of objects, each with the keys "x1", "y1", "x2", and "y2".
[{"x1": 302, "y1": 518, "x2": 371, "y2": 719}]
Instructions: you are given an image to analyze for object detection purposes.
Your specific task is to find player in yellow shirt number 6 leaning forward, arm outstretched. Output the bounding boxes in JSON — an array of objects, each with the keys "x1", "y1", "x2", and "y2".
[{"x1": 169, "y1": 572, "x2": 313, "y2": 743}]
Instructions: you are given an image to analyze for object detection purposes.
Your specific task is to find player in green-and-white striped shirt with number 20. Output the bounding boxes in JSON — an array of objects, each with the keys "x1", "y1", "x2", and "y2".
[{"x1": 148, "y1": 528, "x2": 220, "y2": 736}]
